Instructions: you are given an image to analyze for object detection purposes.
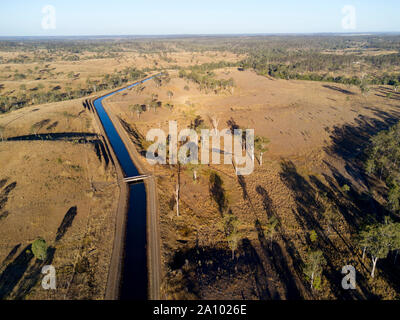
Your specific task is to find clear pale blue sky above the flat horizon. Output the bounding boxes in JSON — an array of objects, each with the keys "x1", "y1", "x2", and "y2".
[{"x1": 0, "y1": 0, "x2": 400, "y2": 36}]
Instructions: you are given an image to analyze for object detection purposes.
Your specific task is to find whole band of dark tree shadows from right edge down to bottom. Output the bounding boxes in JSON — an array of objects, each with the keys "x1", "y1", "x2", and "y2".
[{"x1": 281, "y1": 109, "x2": 400, "y2": 299}]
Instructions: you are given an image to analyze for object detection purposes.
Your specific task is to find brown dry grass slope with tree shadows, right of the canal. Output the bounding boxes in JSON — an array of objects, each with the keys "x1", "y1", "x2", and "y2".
[{"x1": 106, "y1": 68, "x2": 399, "y2": 299}]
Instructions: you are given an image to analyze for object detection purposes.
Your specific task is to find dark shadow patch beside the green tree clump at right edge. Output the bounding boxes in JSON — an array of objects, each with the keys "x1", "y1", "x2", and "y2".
[{"x1": 325, "y1": 107, "x2": 400, "y2": 227}]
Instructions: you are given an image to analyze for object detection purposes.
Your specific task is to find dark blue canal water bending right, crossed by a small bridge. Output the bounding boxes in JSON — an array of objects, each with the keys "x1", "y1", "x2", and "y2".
[{"x1": 93, "y1": 74, "x2": 160, "y2": 300}]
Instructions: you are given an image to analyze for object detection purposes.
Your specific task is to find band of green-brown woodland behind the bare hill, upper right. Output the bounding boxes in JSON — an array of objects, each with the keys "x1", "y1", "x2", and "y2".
[{"x1": 241, "y1": 50, "x2": 400, "y2": 86}]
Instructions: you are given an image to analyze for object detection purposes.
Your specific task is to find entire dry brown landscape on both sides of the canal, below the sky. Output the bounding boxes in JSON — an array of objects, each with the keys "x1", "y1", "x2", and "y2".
[{"x1": 0, "y1": 36, "x2": 400, "y2": 299}]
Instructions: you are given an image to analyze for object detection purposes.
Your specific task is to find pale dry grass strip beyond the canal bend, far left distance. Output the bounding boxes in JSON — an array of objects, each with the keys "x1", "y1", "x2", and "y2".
[{"x1": 0, "y1": 52, "x2": 244, "y2": 99}]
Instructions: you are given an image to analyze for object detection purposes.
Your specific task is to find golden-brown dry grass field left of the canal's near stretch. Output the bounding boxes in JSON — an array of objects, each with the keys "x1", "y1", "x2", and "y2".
[{"x1": 0, "y1": 100, "x2": 119, "y2": 299}]
